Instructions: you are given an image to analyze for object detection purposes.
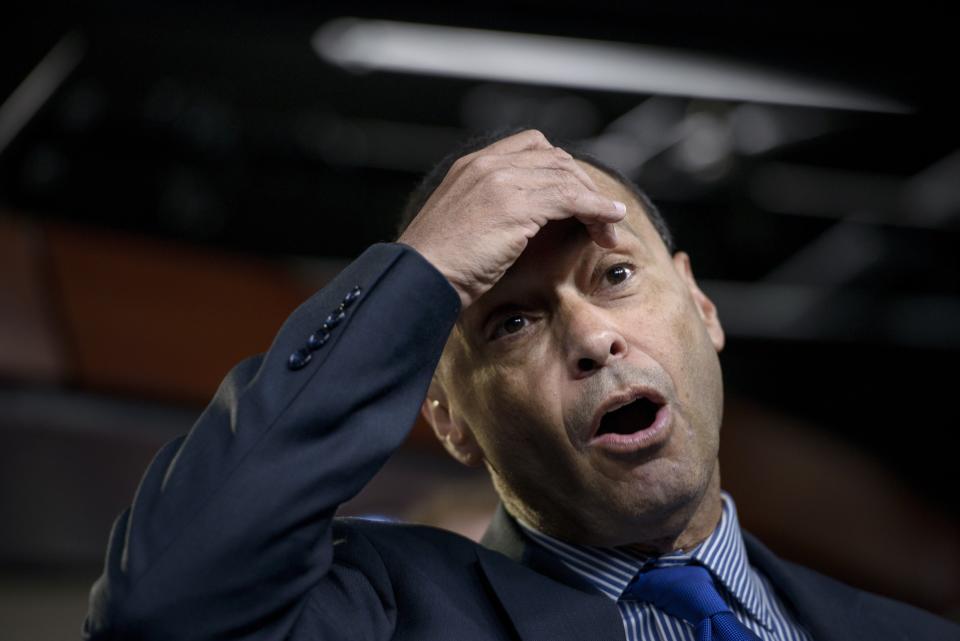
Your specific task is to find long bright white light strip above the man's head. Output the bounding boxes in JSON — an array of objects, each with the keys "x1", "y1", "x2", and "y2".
[{"x1": 313, "y1": 18, "x2": 910, "y2": 113}]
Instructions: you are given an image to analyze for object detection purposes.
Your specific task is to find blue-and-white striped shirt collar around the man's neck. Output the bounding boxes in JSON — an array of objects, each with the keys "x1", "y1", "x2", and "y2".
[{"x1": 517, "y1": 492, "x2": 773, "y2": 630}]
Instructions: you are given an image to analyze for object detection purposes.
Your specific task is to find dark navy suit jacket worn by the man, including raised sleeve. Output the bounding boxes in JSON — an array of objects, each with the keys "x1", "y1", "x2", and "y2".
[{"x1": 84, "y1": 244, "x2": 960, "y2": 641}]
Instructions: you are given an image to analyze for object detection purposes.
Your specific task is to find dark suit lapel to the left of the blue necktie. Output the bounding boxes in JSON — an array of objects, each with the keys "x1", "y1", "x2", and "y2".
[{"x1": 477, "y1": 506, "x2": 624, "y2": 641}]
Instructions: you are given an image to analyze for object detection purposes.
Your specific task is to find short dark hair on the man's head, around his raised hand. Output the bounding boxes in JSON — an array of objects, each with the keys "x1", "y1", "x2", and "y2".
[{"x1": 397, "y1": 127, "x2": 676, "y2": 254}]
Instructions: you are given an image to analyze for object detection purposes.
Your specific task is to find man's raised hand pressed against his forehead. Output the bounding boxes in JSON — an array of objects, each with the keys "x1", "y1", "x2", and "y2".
[{"x1": 399, "y1": 130, "x2": 626, "y2": 309}]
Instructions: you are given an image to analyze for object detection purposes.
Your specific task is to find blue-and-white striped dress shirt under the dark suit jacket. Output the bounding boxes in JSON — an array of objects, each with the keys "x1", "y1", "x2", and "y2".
[{"x1": 520, "y1": 492, "x2": 810, "y2": 641}]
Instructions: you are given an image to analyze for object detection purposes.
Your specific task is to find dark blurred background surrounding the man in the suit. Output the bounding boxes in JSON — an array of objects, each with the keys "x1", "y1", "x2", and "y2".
[{"x1": 0, "y1": 0, "x2": 960, "y2": 641}]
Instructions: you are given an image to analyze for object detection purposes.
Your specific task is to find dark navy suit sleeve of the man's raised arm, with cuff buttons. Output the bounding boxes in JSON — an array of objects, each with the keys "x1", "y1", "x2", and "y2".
[{"x1": 84, "y1": 244, "x2": 460, "y2": 640}]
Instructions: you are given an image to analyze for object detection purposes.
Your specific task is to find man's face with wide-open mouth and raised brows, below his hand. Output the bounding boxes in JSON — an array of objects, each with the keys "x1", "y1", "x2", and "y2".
[{"x1": 437, "y1": 163, "x2": 724, "y2": 545}]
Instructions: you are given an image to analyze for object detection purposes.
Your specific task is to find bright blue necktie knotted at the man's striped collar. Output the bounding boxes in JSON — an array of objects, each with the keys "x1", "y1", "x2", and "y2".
[{"x1": 621, "y1": 565, "x2": 760, "y2": 641}]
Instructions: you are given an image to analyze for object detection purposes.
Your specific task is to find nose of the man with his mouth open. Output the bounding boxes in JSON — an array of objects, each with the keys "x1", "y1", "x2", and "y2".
[{"x1": 566, "y1": 302, "x2": 627, "y2": 378}]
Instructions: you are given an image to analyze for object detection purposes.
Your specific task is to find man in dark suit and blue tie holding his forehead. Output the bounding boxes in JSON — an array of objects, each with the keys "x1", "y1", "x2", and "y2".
[{"x1": 84, "y1": 131, "x2": 960, "y2": 641}]
